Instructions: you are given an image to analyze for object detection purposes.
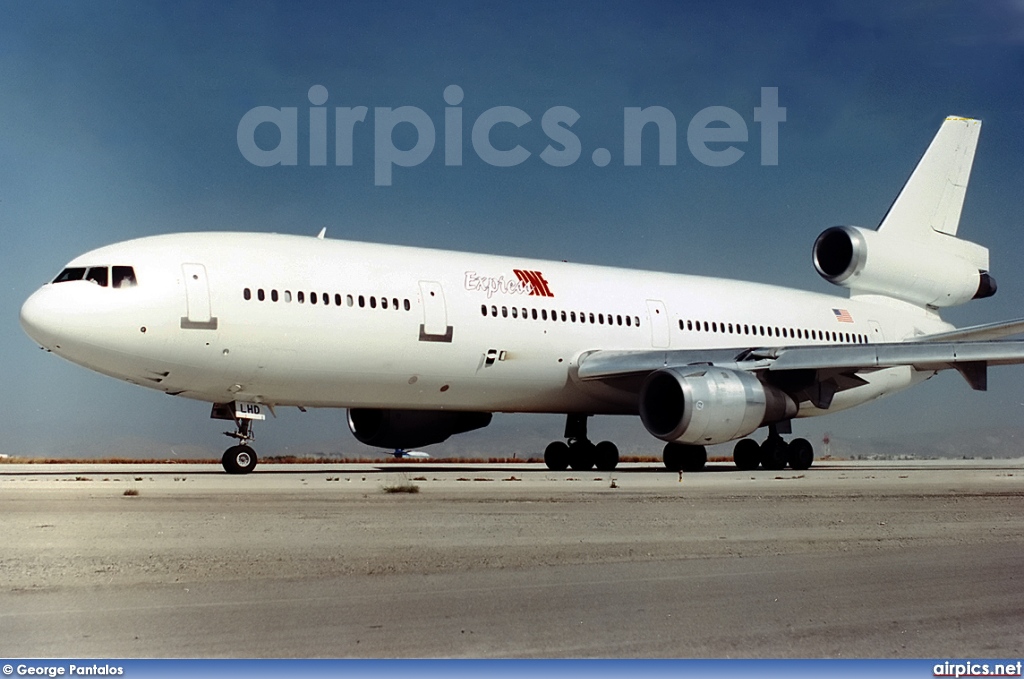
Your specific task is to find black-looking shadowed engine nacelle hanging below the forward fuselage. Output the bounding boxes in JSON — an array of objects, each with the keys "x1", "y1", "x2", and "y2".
[{"x1": 348, "y1": 408, "x2": 490, "y2": 449}]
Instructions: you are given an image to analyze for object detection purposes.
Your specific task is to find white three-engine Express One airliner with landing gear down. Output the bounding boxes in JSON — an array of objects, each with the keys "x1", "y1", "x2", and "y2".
[{"x1": 20, "y1": 117, "x2": 1024, "y2": 473}]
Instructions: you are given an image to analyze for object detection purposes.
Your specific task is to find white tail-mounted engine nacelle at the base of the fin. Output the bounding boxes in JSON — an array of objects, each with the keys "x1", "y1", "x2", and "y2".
[{"x1": 813, "y1": 226, "x2": 996, "y2": 307}]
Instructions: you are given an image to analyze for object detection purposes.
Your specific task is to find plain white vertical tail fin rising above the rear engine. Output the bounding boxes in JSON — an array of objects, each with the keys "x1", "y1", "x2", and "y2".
[{"x1": 879, "y1": 116, "x2": 981, "y2": 239}]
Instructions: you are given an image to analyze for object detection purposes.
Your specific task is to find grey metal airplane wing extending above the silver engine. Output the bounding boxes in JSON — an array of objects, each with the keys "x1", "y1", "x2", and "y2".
[{"x1": 575, "y1": 335, "x2": 1024, "y2": 409}]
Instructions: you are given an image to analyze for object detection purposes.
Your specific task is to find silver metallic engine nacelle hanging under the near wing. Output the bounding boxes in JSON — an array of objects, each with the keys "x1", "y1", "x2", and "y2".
[{"x1": 639, "y1": 367, "x2": 797, "y2": 445}]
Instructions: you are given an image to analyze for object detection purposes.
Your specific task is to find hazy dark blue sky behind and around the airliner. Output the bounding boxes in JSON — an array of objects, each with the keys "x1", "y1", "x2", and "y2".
[{"x1": 0, "y1": 0, "x2": 1024, "y2": 455}]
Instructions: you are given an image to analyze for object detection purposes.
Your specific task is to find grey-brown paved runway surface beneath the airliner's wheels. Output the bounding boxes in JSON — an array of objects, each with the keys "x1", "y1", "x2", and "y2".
[{"x1": 0, "y1": 460, "x2": 1024, "y2": 657}]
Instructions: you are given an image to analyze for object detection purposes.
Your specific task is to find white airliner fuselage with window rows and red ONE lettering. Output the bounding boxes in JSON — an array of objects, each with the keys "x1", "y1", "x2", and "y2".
[{"x1": 22, "y1": 234, "x2": 951, "y2": 416}]
